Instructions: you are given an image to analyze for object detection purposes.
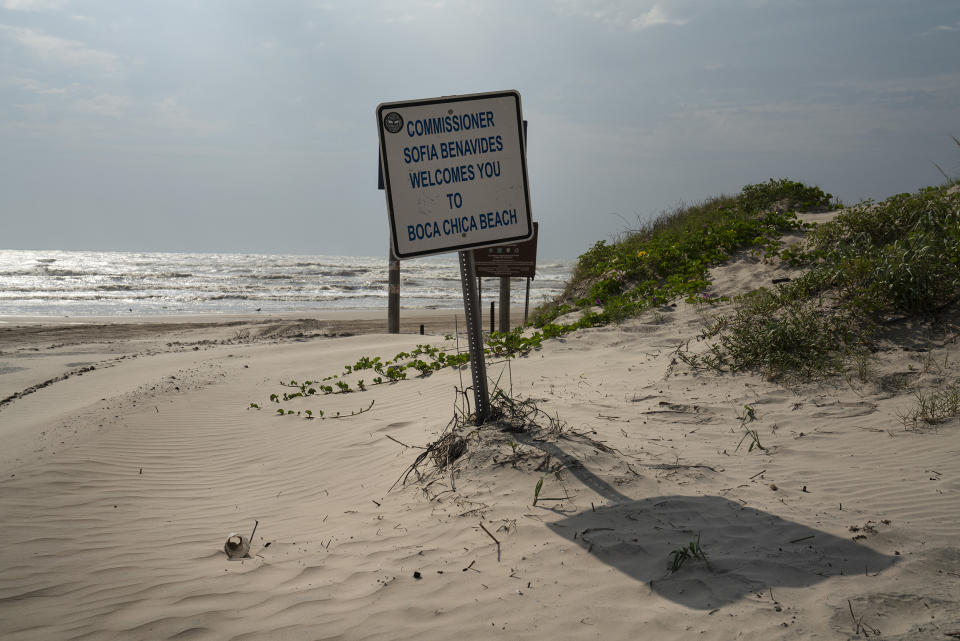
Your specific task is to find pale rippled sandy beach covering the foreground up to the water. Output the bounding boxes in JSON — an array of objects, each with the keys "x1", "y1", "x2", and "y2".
[{"x1": 0, "y1": 280, "x2": 960, "y2": 641}]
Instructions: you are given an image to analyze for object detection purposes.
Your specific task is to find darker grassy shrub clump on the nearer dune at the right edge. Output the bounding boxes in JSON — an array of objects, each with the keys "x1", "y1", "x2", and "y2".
[{"x1": 682, "y1": 185, "x2": 960, "y2": 378}]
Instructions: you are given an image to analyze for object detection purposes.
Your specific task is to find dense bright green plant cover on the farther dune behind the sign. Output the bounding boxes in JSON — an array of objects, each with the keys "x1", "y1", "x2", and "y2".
[{"x1": 532, "y1": 179, "x2": 833, "y2": 331}]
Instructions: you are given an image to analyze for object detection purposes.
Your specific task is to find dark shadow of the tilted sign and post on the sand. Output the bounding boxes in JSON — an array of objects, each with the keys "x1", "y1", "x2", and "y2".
[{"x1": 518, "y1": 438, "x2": 897, "y2": 610}]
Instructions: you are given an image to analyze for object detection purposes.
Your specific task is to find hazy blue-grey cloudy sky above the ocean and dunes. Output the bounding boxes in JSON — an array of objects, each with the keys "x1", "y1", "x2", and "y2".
[{"x1": 0, "y1": 0, "x2": 960, "y2": 259}]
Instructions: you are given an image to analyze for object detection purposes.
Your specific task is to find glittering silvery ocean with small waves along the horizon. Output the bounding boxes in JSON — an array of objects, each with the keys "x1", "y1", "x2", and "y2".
[{"x1": 0, "y1": 250, "x2": 573, "y2": 316}]
